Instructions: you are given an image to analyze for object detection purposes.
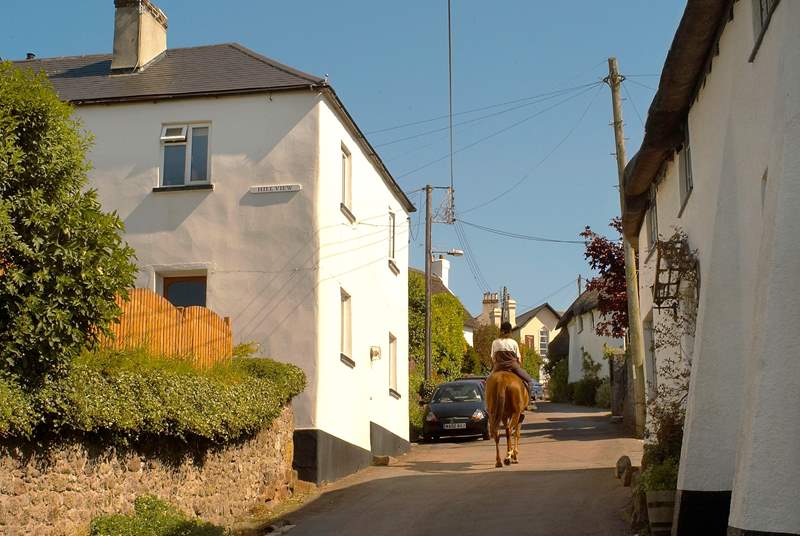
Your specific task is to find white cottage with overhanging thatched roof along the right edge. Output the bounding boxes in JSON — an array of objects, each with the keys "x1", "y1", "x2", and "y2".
[{"x1": 623, "y1": 0, "x2": 800, "y2": 536}]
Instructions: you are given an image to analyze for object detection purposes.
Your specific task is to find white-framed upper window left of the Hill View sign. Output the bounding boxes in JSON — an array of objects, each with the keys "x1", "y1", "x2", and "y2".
[{"x1": 161, "y1": 125, "x2": 209, "y2": 186}]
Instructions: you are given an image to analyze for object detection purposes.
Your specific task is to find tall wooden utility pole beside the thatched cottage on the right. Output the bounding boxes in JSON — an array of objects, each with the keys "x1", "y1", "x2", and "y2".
[{"x1": 606, "y1": 58, "x2": 645, "y2": 437}]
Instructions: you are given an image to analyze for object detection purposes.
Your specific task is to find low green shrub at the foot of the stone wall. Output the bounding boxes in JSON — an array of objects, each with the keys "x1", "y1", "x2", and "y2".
[{"x1": 89, "y1": 495, "x2": 230, "y2": 536}]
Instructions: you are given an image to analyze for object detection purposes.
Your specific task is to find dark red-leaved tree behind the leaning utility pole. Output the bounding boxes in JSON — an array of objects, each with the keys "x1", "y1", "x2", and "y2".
[{"x1": 581, "y1": 218, "x2": 628, "y2": 337}]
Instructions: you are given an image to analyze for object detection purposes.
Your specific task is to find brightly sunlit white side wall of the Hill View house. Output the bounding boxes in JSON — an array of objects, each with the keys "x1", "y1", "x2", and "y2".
[{"x1": 316, "y1": 97, "x2": 409, "y2": 450}]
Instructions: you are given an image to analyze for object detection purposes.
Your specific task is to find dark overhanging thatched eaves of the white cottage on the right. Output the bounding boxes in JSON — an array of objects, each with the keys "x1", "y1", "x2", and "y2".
[{"x1": 622, "y1": 0, "x2": 735, "y2": 241}]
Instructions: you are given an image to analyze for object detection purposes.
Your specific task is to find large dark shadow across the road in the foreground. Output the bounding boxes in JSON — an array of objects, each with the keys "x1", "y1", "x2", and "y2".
[{"x1": 286, "y1": 464, "x2": 629, "y2": 536}]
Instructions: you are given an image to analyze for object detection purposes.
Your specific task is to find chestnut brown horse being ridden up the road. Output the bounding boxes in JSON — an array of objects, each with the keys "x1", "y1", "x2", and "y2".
[{"x1": 486, "y1": 371, "x2": 528, "y2": 467}]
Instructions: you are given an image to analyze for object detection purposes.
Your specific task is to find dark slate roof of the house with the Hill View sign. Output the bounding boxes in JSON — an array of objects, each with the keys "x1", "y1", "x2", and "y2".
[{"x1": 14, "y1": 43, "x2": 326, "y2": 104}]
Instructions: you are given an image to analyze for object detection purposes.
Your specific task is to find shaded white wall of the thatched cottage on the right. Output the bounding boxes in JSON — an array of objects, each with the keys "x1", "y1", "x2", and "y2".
[{"x1": 639, "y1": 2, "x2": 800, "y2": 533}]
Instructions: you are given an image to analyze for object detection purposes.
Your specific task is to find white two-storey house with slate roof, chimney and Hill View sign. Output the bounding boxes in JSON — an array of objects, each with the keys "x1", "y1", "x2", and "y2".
[{"x1": 17, "y1": 0, "x2": 414, "y2": 482}]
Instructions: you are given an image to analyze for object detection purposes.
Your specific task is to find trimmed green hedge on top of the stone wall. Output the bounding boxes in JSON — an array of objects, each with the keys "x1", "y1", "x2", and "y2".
[{"x1": 0, "y1": 351, "x2": 305, "y2": 443}]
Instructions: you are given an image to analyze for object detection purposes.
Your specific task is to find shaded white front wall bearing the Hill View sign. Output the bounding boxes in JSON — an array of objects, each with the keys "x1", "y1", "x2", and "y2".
[{"x1": 77, "y1": 92, "x2": 319, "y2": 426}]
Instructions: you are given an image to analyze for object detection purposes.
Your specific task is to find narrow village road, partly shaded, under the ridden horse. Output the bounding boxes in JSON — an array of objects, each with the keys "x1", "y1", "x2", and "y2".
[{"x1": 287, "y1": 402, "x2": 641, "y2": 536}]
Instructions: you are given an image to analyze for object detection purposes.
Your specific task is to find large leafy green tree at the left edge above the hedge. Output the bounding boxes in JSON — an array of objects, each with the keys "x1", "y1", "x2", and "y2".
[{"x1": 0, "y1": 62, "x2": 135, "y2": 384}]
